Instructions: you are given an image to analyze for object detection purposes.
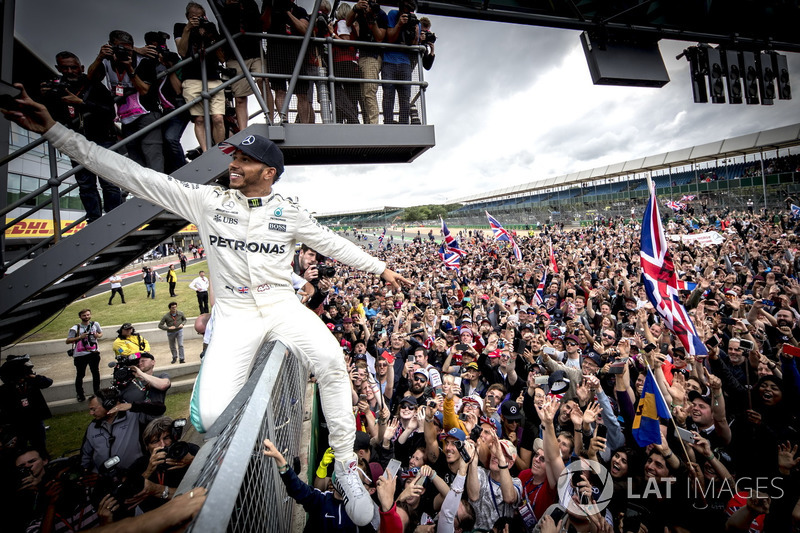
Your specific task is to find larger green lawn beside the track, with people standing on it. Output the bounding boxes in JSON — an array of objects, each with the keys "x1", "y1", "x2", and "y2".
[{"x1": 23, "y1": 261, "x2": 208, "y2": 342}]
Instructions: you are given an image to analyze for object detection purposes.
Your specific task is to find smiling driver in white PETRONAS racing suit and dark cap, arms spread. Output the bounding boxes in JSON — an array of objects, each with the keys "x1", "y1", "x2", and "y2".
[{"x1": 4, "y1": 85, "x2": 410, "y2": 525}]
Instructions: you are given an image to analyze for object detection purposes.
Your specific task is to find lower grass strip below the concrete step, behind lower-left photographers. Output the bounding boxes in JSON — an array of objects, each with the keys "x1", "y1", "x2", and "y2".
[{"x1": 45, "y1": 386, "x2": 192, "y2": 458}]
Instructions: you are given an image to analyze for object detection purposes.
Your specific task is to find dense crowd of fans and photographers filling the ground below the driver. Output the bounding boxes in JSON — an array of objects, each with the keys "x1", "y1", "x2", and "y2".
[{"x1": 0, "y1": 195, "x2": 800, "y2": 533}]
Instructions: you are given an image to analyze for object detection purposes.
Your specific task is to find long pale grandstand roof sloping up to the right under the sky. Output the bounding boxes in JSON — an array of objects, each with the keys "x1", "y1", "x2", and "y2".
[{"x1": 448, "y1": 123, "x2": 800, "y2": 203}]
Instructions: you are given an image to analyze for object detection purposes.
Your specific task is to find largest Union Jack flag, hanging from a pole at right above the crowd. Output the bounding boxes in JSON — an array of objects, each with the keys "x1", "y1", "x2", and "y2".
[{"x1": 640, "y1": 184, "x2": 708, "y2": 356}]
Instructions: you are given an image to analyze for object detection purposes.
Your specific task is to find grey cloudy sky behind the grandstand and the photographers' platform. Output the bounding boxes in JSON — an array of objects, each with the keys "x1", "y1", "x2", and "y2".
[{"x1": 16, "y1": 0, "x2": 800, "y2": 213}]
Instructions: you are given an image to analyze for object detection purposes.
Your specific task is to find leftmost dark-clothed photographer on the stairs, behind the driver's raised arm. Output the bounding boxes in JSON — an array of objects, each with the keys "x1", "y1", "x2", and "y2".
[{"x1": 41, "y1": 51, "x2": 123, "y2": 222}]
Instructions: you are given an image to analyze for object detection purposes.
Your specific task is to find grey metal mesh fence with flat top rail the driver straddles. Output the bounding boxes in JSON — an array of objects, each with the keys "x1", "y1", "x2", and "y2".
[{"x1": 177, "y1": 341, "x2": 308, "y2": 533}]
